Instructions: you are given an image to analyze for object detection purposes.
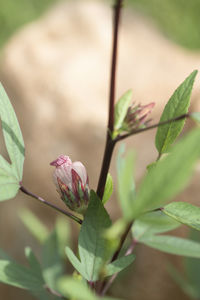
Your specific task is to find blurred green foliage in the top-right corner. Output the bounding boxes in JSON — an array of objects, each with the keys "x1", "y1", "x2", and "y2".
[{"x1": 129, "y1": 0, "x2": 200, "y2": 49}]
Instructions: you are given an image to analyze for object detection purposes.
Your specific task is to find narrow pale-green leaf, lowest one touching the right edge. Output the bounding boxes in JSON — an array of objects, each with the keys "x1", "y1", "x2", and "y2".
[{"x1": 140, "y1": 235, "x2": 200, "y2": 258}]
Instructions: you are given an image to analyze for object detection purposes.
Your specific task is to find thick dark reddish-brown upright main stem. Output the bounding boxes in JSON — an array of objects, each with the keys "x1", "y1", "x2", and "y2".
[{"x1": 97, "y1": 0, "x2": 123, "y2": 199}]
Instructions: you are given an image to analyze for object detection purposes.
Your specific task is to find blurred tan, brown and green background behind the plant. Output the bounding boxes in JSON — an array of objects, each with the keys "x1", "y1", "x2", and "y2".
[{"x1": 0, "y1": 0, "x2": 200, "y2": 300}]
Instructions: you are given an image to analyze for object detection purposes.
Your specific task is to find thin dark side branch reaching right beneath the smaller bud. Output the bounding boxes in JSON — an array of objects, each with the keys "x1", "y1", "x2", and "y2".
[{"x1": 116, "y1": 114, "x2": 190, "y2": 142}]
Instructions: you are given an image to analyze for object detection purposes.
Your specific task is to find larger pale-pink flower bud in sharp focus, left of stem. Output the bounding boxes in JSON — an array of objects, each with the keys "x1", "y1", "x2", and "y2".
[{"x1": 50, "y1": 155, "x2": 89, "y2": 214}]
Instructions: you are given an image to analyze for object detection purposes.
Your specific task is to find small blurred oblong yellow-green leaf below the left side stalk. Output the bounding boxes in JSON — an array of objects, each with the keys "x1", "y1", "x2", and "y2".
[{"x1": 19, "y1": 209, "x2": 49, "y2": 244}]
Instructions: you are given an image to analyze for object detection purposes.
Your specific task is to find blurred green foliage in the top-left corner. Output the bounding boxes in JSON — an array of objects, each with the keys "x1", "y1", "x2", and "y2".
[{"x1": 0, "y1": 0, "x2": 58, "y2": 47}]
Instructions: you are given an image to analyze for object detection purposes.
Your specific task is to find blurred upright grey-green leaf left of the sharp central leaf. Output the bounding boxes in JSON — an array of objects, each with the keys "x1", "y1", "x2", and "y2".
[{"x1": 42, "y1": 230, "x2": 64, "y2": 290}]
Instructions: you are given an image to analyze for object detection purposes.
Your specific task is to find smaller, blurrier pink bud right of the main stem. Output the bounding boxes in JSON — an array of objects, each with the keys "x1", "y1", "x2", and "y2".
[{"x1": 123, "y1": 102, "x2": 155, "y2": 132}]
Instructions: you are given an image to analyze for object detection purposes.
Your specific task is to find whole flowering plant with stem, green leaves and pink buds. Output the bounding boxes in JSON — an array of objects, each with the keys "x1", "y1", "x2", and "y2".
[{"x1": 0, "y1": 0, "x2": 200, "y2": 300}]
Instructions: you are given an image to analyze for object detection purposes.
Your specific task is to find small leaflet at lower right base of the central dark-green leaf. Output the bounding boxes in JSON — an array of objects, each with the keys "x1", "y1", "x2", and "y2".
[{"x1": 106, "y1": 254, "x2": 135, "y2": 276}]
